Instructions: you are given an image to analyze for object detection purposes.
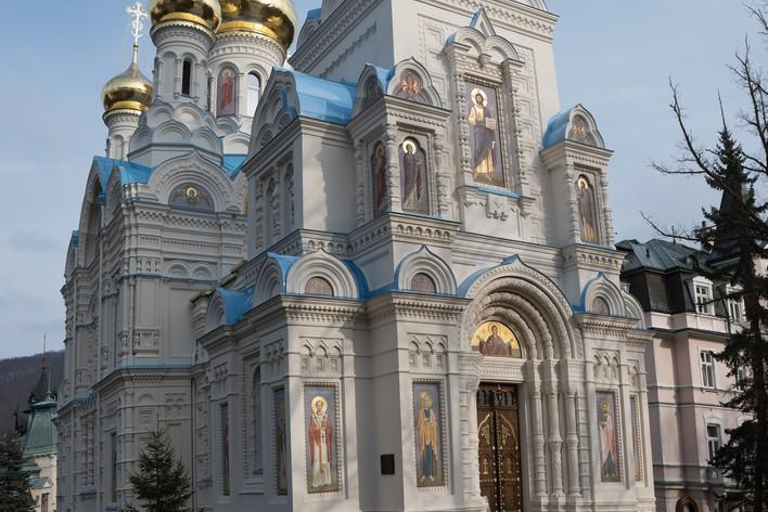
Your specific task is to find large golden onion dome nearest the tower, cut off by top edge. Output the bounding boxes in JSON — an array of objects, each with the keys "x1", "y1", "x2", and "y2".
[{"x1": 218, "y1": 0, "x2": 298, "y2": 50}]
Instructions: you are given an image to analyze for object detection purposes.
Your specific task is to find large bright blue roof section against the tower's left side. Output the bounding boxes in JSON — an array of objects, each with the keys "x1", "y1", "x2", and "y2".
[{"x1": 278, "y1": 69, "x2": 356, "y2": 124}]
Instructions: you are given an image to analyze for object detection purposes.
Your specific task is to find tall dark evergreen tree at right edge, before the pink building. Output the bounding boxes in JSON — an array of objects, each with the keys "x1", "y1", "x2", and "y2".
[{"x1": 654, "y1": 3, "x2": 768, "y2": 504}]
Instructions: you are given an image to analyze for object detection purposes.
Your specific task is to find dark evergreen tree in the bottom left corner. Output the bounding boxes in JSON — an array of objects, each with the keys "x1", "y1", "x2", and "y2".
[{"x1": 0, "y1": 432, "x2": 35, "y2": 512}]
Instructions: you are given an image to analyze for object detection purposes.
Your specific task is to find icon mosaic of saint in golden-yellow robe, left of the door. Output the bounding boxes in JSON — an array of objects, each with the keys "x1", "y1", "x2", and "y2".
[{"x1": 413, "y1": 382, "x2": 445, "y2": 487}]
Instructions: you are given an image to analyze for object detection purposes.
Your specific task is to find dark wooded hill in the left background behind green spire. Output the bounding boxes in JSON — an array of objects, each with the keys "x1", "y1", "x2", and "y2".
[{"x1": 0, "y1": 350, "x2": 64, "y2": 431}]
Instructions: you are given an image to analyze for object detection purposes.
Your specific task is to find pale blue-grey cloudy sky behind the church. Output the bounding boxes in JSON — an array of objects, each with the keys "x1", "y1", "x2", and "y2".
[{"x1": 0, "y1": 0, "x2": 765, "y2": 358}]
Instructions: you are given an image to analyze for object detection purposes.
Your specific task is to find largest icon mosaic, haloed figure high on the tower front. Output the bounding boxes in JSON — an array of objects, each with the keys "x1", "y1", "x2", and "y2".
[{"x1": 464, "y1": 82, "x2": 504, "y2": 187}]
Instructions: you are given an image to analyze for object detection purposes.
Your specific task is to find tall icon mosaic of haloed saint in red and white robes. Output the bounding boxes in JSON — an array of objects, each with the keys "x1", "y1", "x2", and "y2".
[{"x1": 304, "y1": 385, "x2": 339, "y2": 494}]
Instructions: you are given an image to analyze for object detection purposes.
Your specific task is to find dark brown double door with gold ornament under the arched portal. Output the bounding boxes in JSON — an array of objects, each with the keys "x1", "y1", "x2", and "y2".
[{"x1": 477, "y1": 383, "x2": 523, "y2": 512}]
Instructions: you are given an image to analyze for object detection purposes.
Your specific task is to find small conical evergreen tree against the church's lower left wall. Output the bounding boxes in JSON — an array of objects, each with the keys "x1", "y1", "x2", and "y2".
[{"x1": 125, "y1": 432, "x2": 192, "y2": 512}]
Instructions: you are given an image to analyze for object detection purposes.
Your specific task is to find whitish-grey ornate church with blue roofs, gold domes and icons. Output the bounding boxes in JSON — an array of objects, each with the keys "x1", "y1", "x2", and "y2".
[{"x1": 57, "y1": 0, "x2": 655, "y2": 512}]
